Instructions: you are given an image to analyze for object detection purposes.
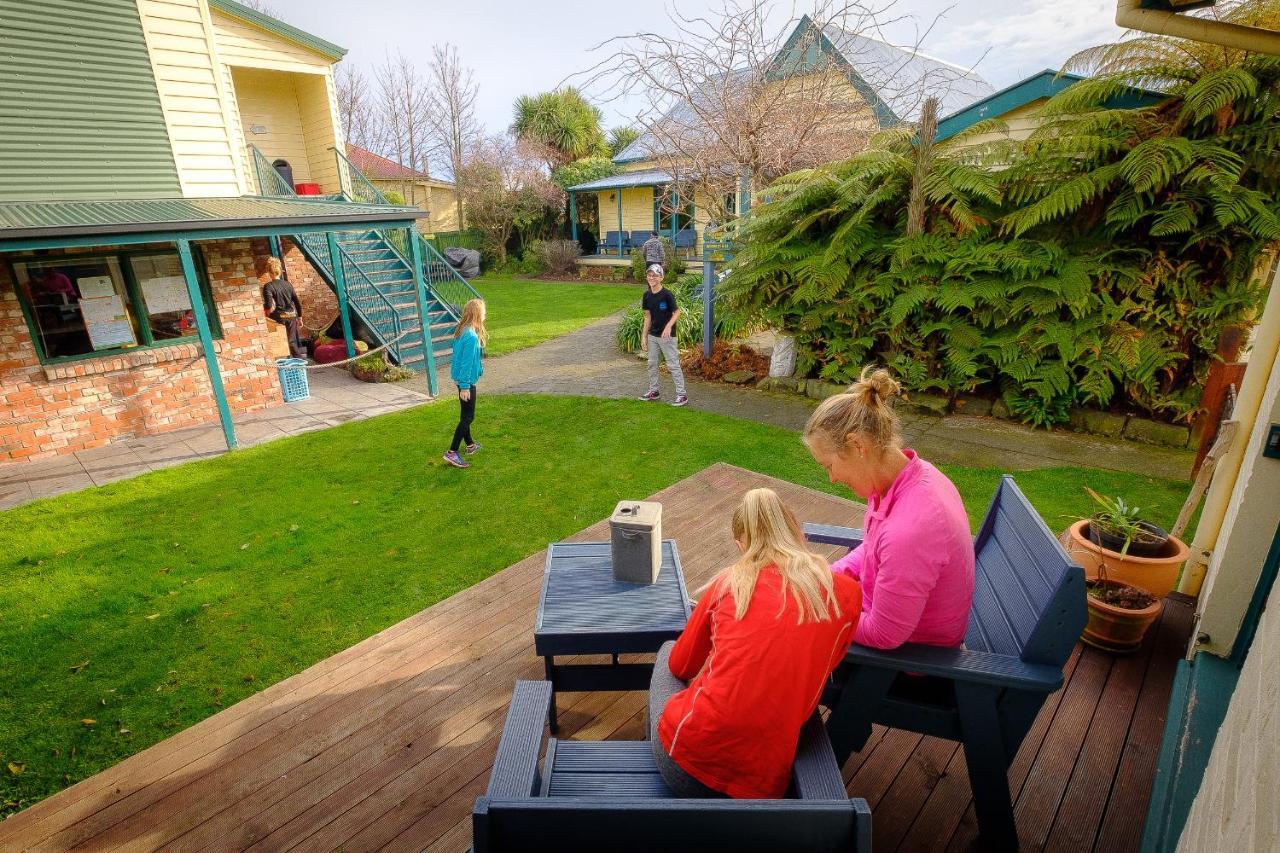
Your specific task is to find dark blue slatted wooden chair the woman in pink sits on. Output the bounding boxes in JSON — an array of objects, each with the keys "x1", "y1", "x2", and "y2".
[{"x1": 805, "y1": 476, "x2": 1087, "y2": 850}]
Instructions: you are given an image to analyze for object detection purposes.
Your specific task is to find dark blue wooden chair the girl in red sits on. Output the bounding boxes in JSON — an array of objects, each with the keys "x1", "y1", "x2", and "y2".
[{"x1": 471, "y1": 681, "x2": 872, "y2": 853}]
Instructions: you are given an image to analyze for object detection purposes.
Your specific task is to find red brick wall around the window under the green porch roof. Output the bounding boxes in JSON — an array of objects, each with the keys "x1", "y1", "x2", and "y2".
[{"x1": 0, "y1": 240, "x2": 280, "y2": 461}]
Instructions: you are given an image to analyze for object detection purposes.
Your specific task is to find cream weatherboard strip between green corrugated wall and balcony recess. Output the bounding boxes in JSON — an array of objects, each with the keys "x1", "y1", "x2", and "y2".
[{"x1": 138, "y1": 0, "x2": 244, "y2": 199}]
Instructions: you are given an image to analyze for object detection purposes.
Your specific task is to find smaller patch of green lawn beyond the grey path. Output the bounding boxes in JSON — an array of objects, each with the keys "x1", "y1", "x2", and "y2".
[{"x1": 472, "y1": 277, "x2": 643, "y2": 356}]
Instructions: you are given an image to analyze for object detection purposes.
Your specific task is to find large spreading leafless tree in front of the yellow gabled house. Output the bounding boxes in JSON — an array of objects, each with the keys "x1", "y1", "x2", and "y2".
[{"x1": 581, "y1": 0, "x2": 967, "y2": 218}]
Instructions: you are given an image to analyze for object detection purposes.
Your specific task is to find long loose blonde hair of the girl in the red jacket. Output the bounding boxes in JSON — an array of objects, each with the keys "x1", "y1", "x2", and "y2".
[{"x1": 699, "y1": 489, "x2": 841, "y2": 624}]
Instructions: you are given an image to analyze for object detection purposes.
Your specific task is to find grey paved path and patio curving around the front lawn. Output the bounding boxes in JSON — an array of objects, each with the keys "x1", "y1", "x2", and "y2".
[{"x1": 0, "y1": 315, "x2": 1193, "y2": 508}]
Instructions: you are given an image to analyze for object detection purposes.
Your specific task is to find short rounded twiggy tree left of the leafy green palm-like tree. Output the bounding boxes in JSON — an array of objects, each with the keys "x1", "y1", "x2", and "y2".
[{"x1": 458, "y1": 133, "x2": 564, "y2": 264}]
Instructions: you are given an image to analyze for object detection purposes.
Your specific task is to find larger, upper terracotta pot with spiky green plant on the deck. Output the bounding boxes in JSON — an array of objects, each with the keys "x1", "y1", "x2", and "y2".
[{"x1": 1061, "y1": 488, "x2": 1189, "y2": 599}]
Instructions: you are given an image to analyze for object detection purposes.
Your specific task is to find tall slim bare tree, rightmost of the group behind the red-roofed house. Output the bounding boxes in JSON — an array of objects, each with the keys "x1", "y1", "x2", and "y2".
[{"x1": 425, "y1": 44, "x2": 484, "y2": 231}]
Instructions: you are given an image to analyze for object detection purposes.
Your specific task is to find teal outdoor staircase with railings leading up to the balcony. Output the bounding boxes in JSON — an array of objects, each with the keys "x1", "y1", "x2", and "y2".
[{"x1": 250, "y1": 145, "x2": 480, "y2": 387}]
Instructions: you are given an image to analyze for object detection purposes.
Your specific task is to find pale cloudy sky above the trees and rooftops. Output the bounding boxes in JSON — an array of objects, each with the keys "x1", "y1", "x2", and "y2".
[{"x1": 266, "y1": 0, "x2": 1121, "y2": 131}]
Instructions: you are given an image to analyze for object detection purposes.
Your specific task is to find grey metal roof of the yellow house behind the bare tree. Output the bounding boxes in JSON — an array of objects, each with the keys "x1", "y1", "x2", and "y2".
[{"x1": 613, "y1": 15, "x2": 995, "y2": 164}]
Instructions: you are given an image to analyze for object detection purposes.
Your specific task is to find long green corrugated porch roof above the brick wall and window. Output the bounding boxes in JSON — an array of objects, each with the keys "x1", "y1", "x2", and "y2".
[{"x1": 0, "y1": 196, "x2": 426, "y2": 250}]
